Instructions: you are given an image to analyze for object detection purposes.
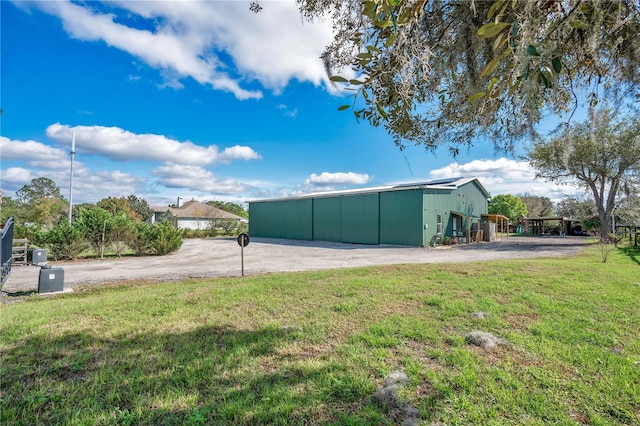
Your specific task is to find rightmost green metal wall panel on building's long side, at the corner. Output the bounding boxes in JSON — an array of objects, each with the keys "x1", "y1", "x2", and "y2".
[{"x1": 380, "y1": 189, "x2": 425, "y2": 246}]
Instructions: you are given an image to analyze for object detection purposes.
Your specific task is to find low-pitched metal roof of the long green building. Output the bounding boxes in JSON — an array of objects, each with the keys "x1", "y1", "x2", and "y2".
[{"x1": 248, "y1": 177, "x2": 491, "y2": 203}]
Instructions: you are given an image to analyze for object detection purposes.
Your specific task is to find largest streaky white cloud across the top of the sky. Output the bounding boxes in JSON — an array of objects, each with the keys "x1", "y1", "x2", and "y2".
[{"x1": 22, "y1": 0, "x2": 337, "y2": 99}]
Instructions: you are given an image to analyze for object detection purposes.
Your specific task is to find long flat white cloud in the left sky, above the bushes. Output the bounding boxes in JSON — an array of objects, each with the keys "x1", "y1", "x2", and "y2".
[{"x1": 47, "y1": 123, "x2": 260, "y2": 166}]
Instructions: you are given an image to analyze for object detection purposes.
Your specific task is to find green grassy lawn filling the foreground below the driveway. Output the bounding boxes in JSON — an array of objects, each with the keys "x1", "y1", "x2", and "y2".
[{"x1": 0, "y1": 246, "x2": 640, "y2": 425}]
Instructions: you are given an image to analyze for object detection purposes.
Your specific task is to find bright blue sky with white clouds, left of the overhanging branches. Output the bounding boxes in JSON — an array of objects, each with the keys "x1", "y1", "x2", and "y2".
[{"x1": 0, "y1": 0, "x2": 576, "y2": 205}]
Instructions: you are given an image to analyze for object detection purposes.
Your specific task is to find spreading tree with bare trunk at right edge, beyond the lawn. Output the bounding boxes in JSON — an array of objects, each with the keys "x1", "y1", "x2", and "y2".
[{"x1": 529, "y1": 108, "x2": 640, "y2": 238}]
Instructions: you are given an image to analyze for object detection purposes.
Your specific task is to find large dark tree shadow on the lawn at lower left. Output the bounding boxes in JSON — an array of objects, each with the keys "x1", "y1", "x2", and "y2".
[{"x1": 0, "y1": 324, "x2": 386, "y2": 425}]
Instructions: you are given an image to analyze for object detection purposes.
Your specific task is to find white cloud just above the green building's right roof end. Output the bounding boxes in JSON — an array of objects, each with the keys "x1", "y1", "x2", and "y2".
[{"x1": 429, "y1": 157, "x2": 584, "y2": 201}]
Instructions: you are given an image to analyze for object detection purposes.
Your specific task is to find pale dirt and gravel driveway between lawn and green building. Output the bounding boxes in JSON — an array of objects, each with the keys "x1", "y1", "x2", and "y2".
[{"x1": 1, "y1": 237, "x2": 586, "y2": 298}]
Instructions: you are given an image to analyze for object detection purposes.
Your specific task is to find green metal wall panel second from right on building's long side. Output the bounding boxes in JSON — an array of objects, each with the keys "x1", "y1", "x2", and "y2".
[{"x1": 340, "y1": 193, "x2": 380, "y2": 244}]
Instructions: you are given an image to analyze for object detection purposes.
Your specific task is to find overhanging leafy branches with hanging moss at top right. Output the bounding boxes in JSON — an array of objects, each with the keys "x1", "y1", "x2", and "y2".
[{"x1": 288, "y1": 0, "x2": 640, "y2": 155}]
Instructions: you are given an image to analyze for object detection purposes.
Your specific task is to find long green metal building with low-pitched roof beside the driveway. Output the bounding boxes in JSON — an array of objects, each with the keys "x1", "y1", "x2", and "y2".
[{"x1": 249, "y1": 178, "x2": 490, "y2": 246}]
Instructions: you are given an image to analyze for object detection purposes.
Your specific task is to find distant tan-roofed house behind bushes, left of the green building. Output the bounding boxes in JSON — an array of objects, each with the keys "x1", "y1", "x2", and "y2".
[{"x1": 151, "y1": 201, "x2": 246, "y2": 229}]
